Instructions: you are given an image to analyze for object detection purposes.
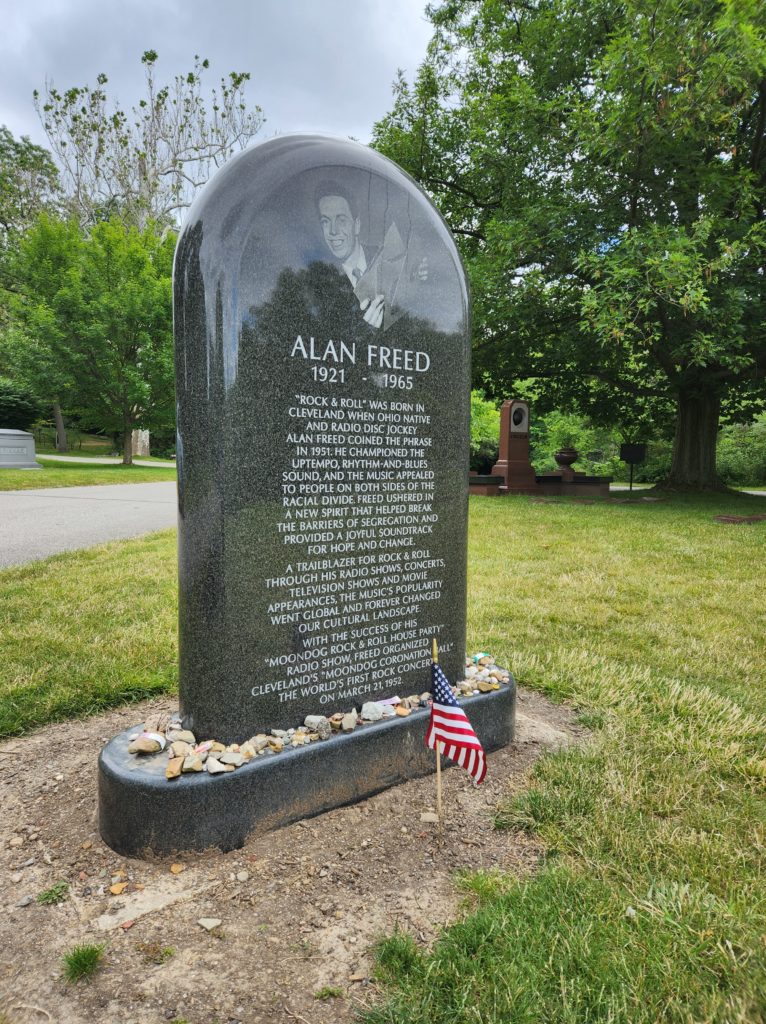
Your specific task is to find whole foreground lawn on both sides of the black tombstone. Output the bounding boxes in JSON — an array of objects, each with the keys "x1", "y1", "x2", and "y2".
[{"x1": 0, "y1": 491, "x2": 766, "y2": 1024}]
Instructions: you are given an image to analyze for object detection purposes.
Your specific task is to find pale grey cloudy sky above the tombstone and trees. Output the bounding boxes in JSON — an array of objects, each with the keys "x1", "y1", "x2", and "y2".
[{"x1": 0, "y1": 0, "x2": 430, "y2": 144}]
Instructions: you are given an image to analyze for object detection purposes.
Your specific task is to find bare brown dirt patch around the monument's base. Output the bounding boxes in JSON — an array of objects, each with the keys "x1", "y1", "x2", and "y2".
[{"x1": 0, "y1": 691, "x2": 584, "y2": 1024}]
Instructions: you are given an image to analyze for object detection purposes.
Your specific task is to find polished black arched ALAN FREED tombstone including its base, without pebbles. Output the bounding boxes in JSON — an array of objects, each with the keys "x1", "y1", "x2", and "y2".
[{"x1": 101, "y1": 135, "x2": 512, "y2": 852}]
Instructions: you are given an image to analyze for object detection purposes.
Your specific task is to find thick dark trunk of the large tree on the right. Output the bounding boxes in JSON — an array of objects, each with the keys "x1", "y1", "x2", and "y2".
[{"x1": 663, "y1": 390, "x2": 725, "y2": 490}]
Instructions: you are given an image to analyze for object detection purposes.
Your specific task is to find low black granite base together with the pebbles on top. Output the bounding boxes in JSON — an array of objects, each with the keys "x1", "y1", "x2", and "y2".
[{"x1": 98, "y1": 654, "x2": 516, "y2": 857}]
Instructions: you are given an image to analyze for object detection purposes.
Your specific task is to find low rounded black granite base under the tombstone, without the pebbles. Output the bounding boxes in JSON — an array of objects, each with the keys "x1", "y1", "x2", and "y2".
[{"x1": 98, "y1": 680, "x2": 516, "y2": 857}]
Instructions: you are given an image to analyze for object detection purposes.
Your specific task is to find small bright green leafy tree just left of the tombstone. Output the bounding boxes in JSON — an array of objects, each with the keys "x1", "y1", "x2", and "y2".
[{"x1": 15, "y1": 215, "x2": 175, "y2": 464}]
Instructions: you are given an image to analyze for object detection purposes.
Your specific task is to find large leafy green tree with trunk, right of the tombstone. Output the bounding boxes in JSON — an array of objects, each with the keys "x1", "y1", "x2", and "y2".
[{"x1": 375, "y1": 0, "x2": 766, "y2": 487}]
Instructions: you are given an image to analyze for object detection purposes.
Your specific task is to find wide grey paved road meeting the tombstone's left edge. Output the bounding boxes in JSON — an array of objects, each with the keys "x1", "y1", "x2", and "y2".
[{"x1": 0, "y1": 480, "x2": 177, "y2": 567}]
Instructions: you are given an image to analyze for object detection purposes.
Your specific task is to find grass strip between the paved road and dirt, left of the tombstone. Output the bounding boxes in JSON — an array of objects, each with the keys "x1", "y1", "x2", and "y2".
[{"x1": 0, "y1": 528, "x2": 177, "y2": 735}]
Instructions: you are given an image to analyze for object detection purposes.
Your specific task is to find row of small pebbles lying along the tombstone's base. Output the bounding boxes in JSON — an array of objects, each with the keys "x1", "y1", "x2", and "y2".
[{"x1": 128, "y1": 652, "x2": 511, "y2": 781}]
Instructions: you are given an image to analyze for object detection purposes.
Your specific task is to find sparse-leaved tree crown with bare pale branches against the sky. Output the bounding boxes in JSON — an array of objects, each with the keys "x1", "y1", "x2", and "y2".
[{"x1": 35, "y1": 50, "x2": 263, "y2": 228}]
